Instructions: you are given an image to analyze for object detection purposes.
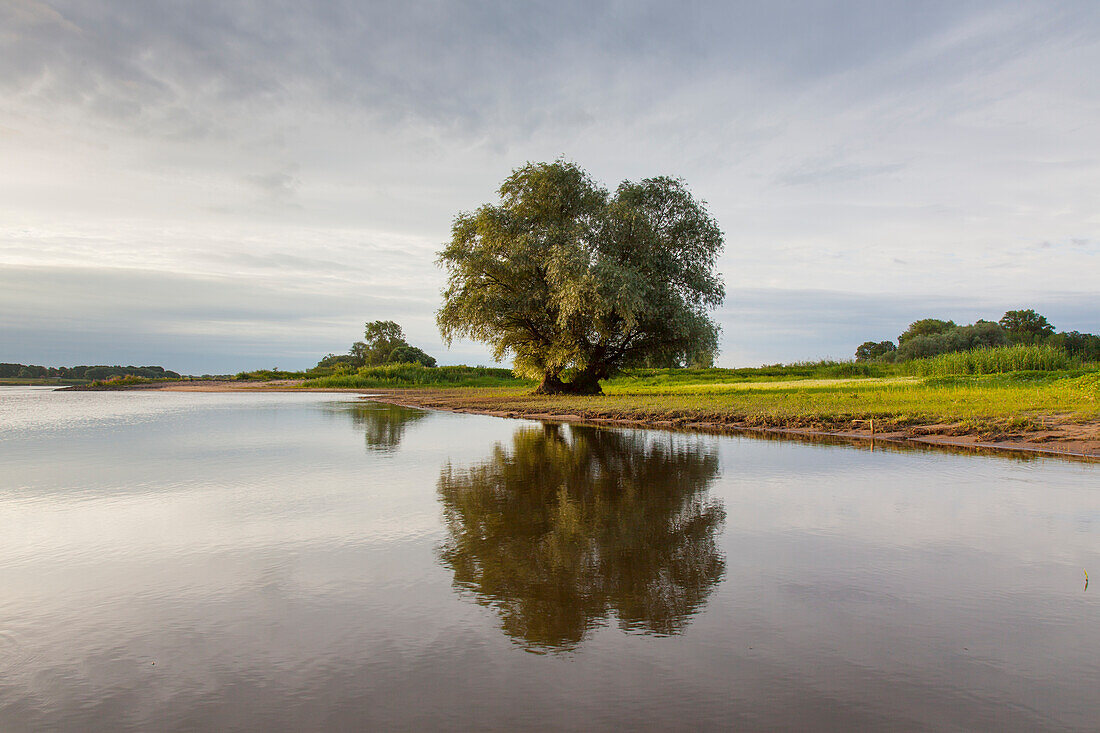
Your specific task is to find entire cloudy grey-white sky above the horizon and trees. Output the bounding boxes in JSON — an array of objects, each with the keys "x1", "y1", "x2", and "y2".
[{"x1": 0, "y1": 0, "x2": 1100, "y2": 373}]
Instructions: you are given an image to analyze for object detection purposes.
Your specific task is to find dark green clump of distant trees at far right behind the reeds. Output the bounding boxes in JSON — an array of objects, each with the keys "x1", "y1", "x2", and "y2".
[{"x1": 856, "y1": 308, "x2": 1100, "y2": 362}]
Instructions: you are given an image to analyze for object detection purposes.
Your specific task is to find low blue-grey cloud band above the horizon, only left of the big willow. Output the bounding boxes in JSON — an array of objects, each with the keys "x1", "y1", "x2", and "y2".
[{"x1": 0, "y1": 266, "x2": 442, "y2": 373}]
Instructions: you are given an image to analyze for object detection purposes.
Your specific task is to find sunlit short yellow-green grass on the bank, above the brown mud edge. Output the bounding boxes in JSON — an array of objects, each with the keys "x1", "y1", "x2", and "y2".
[{"x1": 382, "y1": 347, "x2": 1100, "y2": 435}]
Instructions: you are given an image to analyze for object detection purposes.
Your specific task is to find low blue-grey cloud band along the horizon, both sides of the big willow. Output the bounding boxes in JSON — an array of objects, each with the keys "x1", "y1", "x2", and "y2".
[{"x1": 0, "y1": 267, "x2": 1100, "y2": 373}]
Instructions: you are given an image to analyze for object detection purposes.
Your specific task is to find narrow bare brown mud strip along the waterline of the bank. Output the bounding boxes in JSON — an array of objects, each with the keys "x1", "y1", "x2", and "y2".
[{"x1": 101, "y1": 380, "x2": 1100, "y2": 462}]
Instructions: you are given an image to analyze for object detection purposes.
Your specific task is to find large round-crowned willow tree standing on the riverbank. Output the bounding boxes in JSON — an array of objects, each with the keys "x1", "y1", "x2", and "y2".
[{"x1": 437, "y1": 161, "x2": 725, "y2": 394}]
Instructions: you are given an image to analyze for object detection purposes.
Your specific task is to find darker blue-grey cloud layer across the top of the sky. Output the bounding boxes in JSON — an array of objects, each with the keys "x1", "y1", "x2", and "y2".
[{"x1": 0, "y1": 0, "x2": 1089, "y2": 135}]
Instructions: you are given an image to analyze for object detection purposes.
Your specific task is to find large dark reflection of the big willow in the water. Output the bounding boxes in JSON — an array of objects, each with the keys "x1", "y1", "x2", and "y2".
[{"x1": 439, "y1": 425, "x2": 725, "y2": 650}]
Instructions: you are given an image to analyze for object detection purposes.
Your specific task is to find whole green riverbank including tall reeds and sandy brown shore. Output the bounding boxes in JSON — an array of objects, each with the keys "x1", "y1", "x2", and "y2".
[{"x1": 88, "y1": 347, "x2": 1100, "y2": 455}]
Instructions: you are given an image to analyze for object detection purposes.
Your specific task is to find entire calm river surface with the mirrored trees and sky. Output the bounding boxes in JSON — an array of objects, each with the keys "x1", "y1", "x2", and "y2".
[{"x1": 0, "y1": 387, "x2": 1100, "y2": 731}]
